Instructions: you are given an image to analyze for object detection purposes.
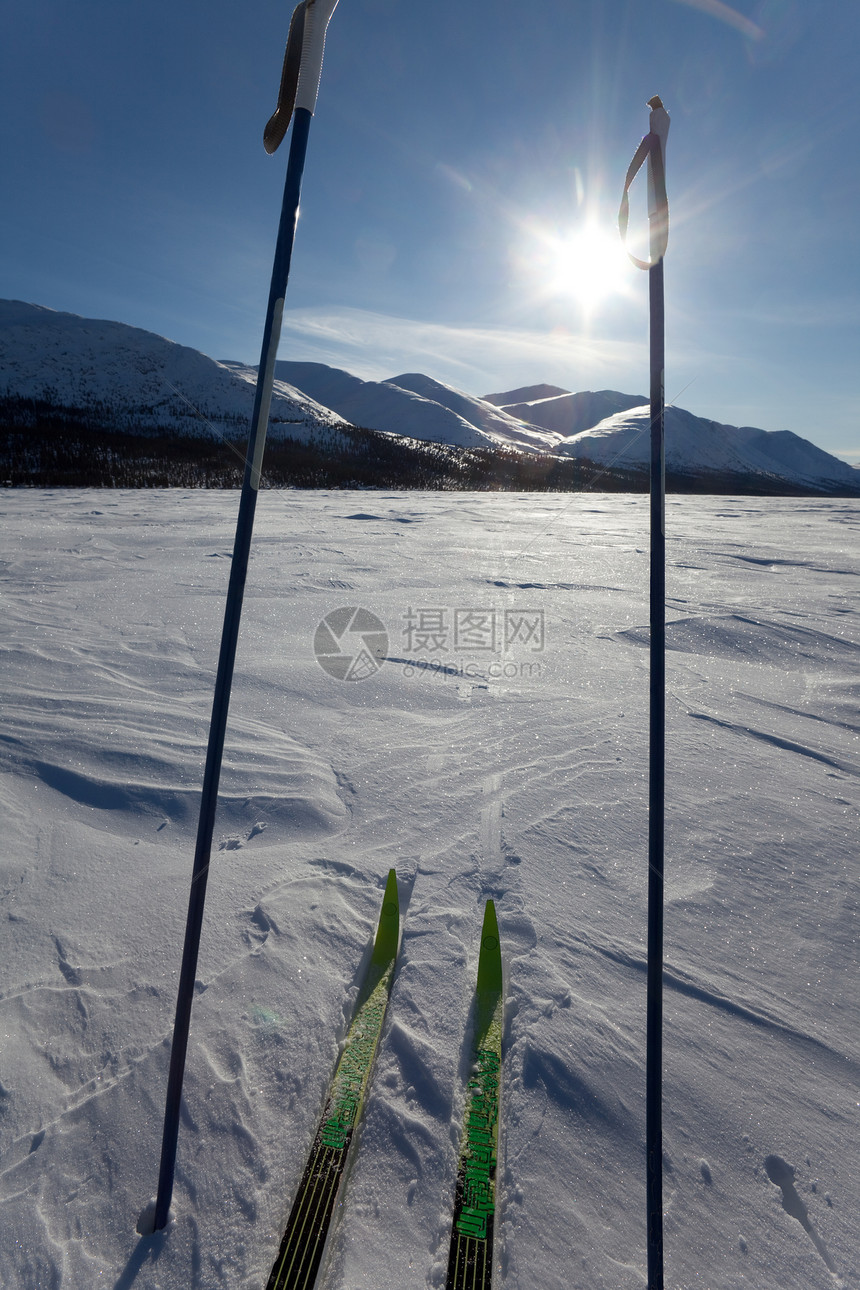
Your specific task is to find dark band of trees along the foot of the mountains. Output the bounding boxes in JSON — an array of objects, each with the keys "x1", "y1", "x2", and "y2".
[{"x1": 0, "y1": 396, "x2": 845, "y2": 495}]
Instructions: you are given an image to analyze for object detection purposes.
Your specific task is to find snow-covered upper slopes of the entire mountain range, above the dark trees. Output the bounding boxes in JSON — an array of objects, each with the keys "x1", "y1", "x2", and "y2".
[{"x1": 0, "y1": 301, "x2": 859, "y2": 493}]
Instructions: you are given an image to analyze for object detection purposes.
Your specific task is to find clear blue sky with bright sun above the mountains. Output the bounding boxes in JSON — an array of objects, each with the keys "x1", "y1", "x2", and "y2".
[{"x1": 0, "y1": 0, "x2": 860, "y2": 463}]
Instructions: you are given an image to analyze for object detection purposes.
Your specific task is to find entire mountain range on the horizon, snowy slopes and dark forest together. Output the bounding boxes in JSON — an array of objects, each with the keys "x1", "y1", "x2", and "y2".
[{"x1": 0, "y1": 301, "x2": 860, "y2": 495}]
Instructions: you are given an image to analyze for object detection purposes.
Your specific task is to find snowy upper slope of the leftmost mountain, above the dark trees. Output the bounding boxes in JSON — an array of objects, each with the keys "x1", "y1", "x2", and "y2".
[{"x1": 0, "y1": 301, "x2": 343, "y2": 437}]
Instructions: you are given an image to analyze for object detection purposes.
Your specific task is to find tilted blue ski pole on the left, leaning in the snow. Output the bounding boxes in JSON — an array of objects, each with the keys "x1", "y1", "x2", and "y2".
[{"x1": 153, "y1": 0, "x2": 338, "y2": 1231}]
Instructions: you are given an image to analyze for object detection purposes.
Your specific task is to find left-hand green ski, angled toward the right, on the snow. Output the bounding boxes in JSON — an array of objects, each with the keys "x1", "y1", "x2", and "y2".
[{"x1": 266, "y1": 869, "x2": 400, "y2": 1290}]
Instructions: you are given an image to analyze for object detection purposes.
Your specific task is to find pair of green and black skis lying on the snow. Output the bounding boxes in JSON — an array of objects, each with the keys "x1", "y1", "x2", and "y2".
[{"x1": 266, "y1": 869, "x2": 504, "y2": 1290}]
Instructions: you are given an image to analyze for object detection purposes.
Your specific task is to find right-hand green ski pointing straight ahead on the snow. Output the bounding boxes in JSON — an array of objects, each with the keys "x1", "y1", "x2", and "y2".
[{"x1": 445, "y1": 900, "x2": 504, "y2": 1290}]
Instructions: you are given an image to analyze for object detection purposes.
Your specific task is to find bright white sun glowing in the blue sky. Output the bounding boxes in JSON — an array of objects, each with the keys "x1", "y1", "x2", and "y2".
[{"x1": 525, "y1": 223, "x2": 630, "y2": 315}]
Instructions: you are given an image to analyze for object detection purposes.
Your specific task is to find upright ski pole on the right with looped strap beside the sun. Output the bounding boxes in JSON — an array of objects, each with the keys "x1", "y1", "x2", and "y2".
[{"x1": 626, "y1": 95, "x2": 669, "y2": 1290}]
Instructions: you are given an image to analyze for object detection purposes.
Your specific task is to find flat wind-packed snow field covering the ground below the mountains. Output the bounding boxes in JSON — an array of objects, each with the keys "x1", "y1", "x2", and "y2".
[{"x1": 0, "y1": 489, "x2": 860, "y2": 1290}]
